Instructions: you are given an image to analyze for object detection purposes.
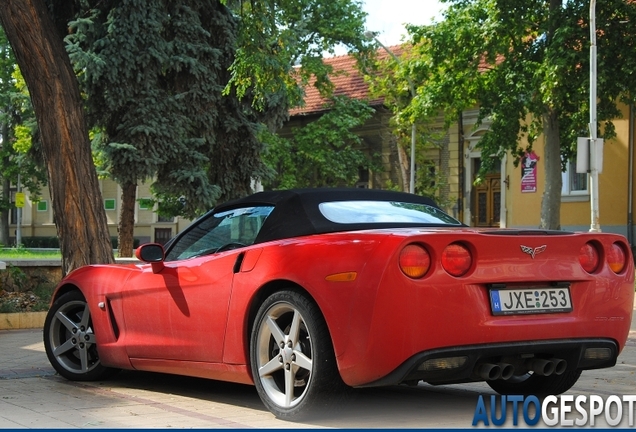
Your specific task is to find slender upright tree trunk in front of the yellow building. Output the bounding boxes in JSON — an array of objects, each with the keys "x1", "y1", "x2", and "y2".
[{"x1": 539, "y1": 110, "x2": 563, "y2": 230}]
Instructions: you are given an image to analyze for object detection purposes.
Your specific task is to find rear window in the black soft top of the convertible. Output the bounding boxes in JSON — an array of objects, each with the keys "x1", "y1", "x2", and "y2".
[{"x1": 319, "y1": 201, "x2": 461, "y2": 225}]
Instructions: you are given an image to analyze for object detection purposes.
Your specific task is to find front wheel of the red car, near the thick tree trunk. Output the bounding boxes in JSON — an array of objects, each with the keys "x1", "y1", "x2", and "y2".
[{"x1": 44, "y1": 291, "x2": 118, "y2": 381}]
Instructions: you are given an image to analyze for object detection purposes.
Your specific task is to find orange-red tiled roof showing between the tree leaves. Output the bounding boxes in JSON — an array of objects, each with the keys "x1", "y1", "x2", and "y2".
[{"x1": 289, "y1": 46, "x2": 402, "y2": 117}]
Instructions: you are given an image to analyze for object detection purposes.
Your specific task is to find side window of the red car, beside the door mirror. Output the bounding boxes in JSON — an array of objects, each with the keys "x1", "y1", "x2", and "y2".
[{"x1": 166, "y1": 206, "x2": 274, "y2": 261}]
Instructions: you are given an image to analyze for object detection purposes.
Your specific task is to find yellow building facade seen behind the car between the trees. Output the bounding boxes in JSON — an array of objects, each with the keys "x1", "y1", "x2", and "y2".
[{"x1": 449, "y1": 101, "x2": 635, "y2": 244}]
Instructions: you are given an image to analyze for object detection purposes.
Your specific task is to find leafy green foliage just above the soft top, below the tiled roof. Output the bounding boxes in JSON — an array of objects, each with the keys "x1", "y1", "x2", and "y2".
[{"x1": 263, "y1": 97, "x2": 381, "y2": 189}]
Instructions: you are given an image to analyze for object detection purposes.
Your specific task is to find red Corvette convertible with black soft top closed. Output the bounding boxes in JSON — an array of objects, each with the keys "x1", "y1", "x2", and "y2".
[{"x1": 44, "y1": 189, "x2": 634, "y2": 419}]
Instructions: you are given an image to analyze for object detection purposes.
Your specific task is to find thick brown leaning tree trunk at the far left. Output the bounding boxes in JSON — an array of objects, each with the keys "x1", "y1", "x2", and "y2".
[{"x1": 0, "y1": 0, "x2": 114, "y2": 274}]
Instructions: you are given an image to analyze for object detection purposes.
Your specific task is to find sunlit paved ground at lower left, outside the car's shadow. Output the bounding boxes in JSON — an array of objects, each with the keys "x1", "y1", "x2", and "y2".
[{"x1": 0, "y1": 329, "x2": 300, "y2": 429}]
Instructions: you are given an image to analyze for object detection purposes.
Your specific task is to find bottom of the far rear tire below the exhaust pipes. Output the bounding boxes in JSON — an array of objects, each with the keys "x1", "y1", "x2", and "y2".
[{"x1": 486, "y1": 370, "x2": 581, "y2": 396}]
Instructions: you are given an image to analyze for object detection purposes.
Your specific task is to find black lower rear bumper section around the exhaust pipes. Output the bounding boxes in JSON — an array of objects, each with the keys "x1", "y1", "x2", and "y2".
[{"x1": 360, "y1": 339, "x2": 618, "y2": 387}]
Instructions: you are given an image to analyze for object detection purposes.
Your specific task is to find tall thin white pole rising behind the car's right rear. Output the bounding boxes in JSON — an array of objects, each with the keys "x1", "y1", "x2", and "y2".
[{"x1": 590, "y1": 0, "x2": 601, "y2": 232}]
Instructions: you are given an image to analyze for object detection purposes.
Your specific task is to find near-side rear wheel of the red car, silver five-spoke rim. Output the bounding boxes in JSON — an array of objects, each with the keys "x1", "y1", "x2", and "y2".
[{"x1": 250, "y1": 290, "x2": 349, "y2": 421}]
